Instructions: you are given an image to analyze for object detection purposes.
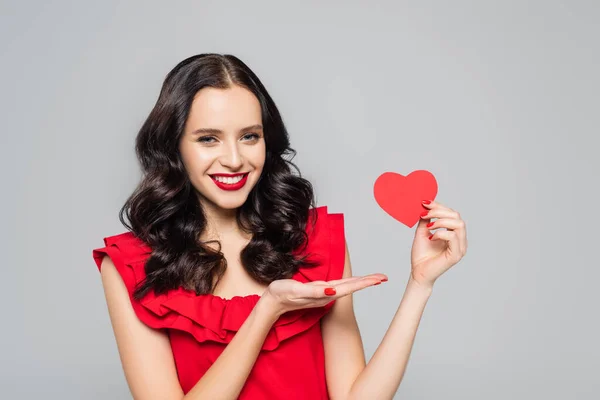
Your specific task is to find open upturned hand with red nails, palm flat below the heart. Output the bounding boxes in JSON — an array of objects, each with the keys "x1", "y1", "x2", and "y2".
[{"x1": 263, "y1": 274, "x2": 387, "y2": 315}]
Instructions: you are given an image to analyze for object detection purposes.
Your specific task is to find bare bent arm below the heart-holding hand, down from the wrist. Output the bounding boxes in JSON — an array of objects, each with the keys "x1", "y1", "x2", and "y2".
[{"x1": 321, "y1": 241, "x2": 432, "y2": 400}]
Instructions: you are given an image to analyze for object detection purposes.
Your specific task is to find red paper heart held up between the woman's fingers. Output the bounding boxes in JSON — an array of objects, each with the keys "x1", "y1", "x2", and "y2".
[{"x1": 373, "y1": 170, "x2": 438, "y2": 228}]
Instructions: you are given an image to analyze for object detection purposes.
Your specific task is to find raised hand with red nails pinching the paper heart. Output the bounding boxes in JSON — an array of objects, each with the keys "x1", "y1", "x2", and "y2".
[{"x1": 411, "y1": 201, "x2": 467, "y2": 287}]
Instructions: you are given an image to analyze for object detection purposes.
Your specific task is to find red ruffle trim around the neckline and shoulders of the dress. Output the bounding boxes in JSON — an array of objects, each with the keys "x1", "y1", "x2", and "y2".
[{"x1": 93, "y1": 206, "x2": 345, "y2": 350}]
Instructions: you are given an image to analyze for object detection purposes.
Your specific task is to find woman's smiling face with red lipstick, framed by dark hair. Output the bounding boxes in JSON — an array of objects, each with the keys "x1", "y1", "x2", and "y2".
[{"x1": 179, "y1": 85, "x2": 266, "y2": 212}]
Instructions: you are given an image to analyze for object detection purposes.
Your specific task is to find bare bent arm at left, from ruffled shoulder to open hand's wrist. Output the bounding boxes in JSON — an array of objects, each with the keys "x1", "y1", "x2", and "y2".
[{"x1": 101, "y1": 257, "x2": 281, "y2": 400}]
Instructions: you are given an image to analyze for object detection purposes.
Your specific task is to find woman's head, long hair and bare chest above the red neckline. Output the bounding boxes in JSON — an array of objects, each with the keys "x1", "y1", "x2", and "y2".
[{"x1": 107, "y1": 54, "x2": 315, "y2": 300}]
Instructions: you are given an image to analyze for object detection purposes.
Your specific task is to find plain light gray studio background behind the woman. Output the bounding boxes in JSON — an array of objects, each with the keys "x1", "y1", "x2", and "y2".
[{"x1": 0, "y1": 1, "x2": 600, "y2": 400}]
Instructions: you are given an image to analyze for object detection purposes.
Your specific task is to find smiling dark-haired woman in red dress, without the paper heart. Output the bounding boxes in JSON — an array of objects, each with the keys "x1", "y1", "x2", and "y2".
[{"x1": 93, "y1": 54, "x2": 467, "y2": 400}]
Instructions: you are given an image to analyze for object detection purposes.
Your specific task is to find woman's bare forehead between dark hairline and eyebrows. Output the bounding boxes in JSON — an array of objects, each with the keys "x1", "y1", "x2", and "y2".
[{"x1": 187, "y1": 85, "x2": 262, "y2": 130}]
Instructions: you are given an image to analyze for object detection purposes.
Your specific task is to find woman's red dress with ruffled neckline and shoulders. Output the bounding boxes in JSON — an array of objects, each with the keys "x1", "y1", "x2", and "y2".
[{"x1": 93, "y1": 206, "x2": 345, "y2": 400}]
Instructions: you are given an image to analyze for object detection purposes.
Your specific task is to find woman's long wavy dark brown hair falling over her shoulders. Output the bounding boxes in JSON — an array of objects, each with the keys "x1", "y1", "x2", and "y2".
[{"x1": 119, "y1": 53, "x2": 324, "y2": 300}]
